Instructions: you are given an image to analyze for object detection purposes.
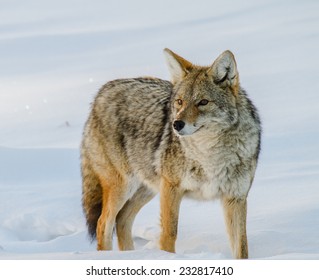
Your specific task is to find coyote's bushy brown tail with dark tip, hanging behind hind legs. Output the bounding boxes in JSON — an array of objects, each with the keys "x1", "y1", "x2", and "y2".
[{"x1": 82, "y1": 162, "x2": 102, "y2": 240}]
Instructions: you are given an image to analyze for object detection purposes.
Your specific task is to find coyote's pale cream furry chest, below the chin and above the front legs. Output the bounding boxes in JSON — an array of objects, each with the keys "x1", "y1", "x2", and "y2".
[{"x1": 181, "y1": 136, "x2": 250, "y2": 200}]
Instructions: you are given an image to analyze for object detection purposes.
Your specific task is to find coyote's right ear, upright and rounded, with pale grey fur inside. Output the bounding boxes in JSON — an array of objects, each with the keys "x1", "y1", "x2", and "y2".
[{"x1": 208, "y1": 51, "x2": 239, "y2": 95}]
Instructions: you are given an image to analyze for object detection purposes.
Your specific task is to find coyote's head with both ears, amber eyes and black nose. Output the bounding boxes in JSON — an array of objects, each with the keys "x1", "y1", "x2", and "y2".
[{"x1": 164, "y1": 49, "x2": 239, "y2": 136}]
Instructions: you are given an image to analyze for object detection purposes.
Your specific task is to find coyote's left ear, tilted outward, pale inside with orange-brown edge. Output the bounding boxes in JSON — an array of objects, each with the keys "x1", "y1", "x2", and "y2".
[{"x1": 164, "y1": 49, "x2": 193, "y2": 84}]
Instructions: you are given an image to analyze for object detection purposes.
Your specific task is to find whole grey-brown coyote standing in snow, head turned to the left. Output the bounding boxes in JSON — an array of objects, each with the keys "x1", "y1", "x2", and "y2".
[{"x1": 81, "y1": 49, "x2": 261, "y2": 258}]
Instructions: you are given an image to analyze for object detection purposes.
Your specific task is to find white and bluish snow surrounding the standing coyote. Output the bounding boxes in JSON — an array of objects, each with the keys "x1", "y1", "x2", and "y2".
[{"x1": 0, "y1": 0, "x2": 319, "y2": 259}]
